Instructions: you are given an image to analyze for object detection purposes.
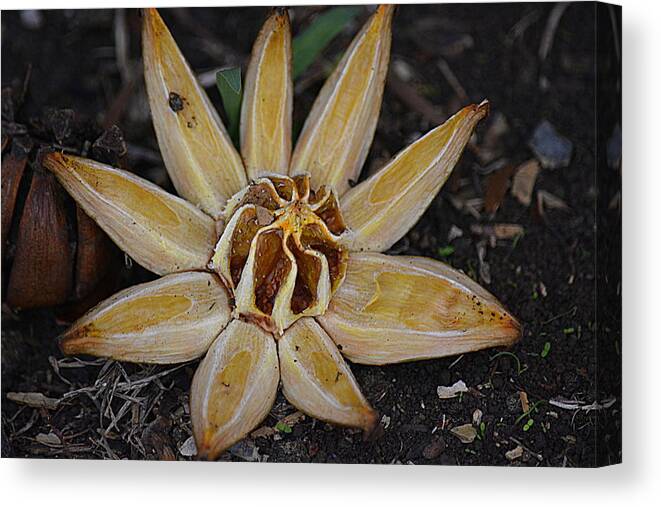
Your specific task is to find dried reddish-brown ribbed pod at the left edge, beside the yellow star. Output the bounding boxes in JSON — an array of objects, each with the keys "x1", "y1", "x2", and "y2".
[{"x1": 1, "y1": 89, "x2": 126, "y2": 320}]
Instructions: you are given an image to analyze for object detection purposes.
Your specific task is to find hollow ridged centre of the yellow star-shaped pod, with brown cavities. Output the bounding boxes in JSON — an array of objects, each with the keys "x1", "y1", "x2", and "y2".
[{"x1": 210, "y1": 174, "x2": 349, "y2": 334}]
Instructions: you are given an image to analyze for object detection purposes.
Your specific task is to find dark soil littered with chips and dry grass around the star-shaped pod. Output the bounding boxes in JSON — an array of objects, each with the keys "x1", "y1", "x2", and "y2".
[{"x1": 2, "y1": 3, "x2": 621, "y2": 467}]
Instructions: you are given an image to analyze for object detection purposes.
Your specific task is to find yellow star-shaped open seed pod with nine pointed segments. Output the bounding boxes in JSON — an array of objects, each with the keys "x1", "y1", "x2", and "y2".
[{"x1": 44, "y1": 5, "x2": 520, "y2": 459}]
